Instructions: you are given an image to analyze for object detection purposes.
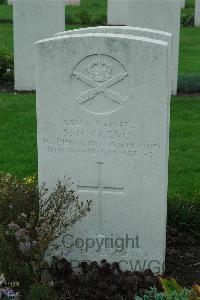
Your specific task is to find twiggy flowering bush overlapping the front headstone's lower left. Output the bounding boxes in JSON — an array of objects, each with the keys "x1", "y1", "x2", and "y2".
[{"x1": 0, "y1": 173, "x2": 91, "y2": 297}]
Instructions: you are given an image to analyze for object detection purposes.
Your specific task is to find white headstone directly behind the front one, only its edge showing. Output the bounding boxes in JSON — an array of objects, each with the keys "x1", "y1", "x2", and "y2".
[{"x1": 55, "y1": 26, "x2": 173, "y2": 93}]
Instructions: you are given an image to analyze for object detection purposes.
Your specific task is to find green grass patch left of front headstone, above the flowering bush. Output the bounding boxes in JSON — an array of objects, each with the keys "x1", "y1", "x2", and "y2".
[{"x1": 0, "y1": 94, "x2": 37, "y2": 177}]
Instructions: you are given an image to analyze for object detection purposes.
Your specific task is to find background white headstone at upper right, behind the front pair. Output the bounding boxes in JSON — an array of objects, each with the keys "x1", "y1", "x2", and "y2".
[{"x1": 108, "y1": 0, "x2": 181, "y2": 95}]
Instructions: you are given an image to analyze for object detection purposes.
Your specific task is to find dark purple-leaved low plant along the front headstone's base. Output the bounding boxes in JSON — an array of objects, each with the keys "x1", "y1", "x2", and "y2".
[{"x1": 36, "y1": 258, "x2": 160, "y2": 300}]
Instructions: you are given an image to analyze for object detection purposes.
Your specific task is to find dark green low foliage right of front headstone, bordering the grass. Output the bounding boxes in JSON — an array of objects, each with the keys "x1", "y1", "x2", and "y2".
[{"x1": 167, "y1": 199, "x2": 200, "y2": 235}]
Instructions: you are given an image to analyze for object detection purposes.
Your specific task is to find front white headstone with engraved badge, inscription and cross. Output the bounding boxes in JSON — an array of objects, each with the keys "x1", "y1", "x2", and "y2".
[{"x1": 36, "y1": 33, "x2": 169, "y2": 272}]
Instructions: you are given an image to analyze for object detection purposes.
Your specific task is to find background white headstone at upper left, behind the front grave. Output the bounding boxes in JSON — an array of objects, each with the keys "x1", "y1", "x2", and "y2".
[{"x1": 13, "y1": 0, "x2": 65, "y2": 90}]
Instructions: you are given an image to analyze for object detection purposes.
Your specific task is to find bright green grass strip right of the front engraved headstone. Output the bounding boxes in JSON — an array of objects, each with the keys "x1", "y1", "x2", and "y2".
[{"x1": 169, "y1": 97, "x2": 200, "y2": 200}]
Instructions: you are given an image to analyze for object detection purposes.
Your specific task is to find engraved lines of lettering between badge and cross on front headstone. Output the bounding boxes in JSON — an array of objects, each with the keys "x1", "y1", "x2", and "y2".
[{"x1": 42, "y1": 120, "x2": 160, "y2": 158}]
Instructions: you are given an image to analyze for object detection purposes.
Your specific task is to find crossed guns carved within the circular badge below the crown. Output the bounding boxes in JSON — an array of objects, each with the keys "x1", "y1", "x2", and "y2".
[{"x1": 73, "y1": 71, "x2": 128, "y2": 105}]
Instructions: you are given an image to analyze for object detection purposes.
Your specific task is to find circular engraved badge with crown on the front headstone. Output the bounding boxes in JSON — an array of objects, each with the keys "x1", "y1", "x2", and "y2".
[{"x1": 72, "y1": 54, "x2": 128, "y2": 114}]
